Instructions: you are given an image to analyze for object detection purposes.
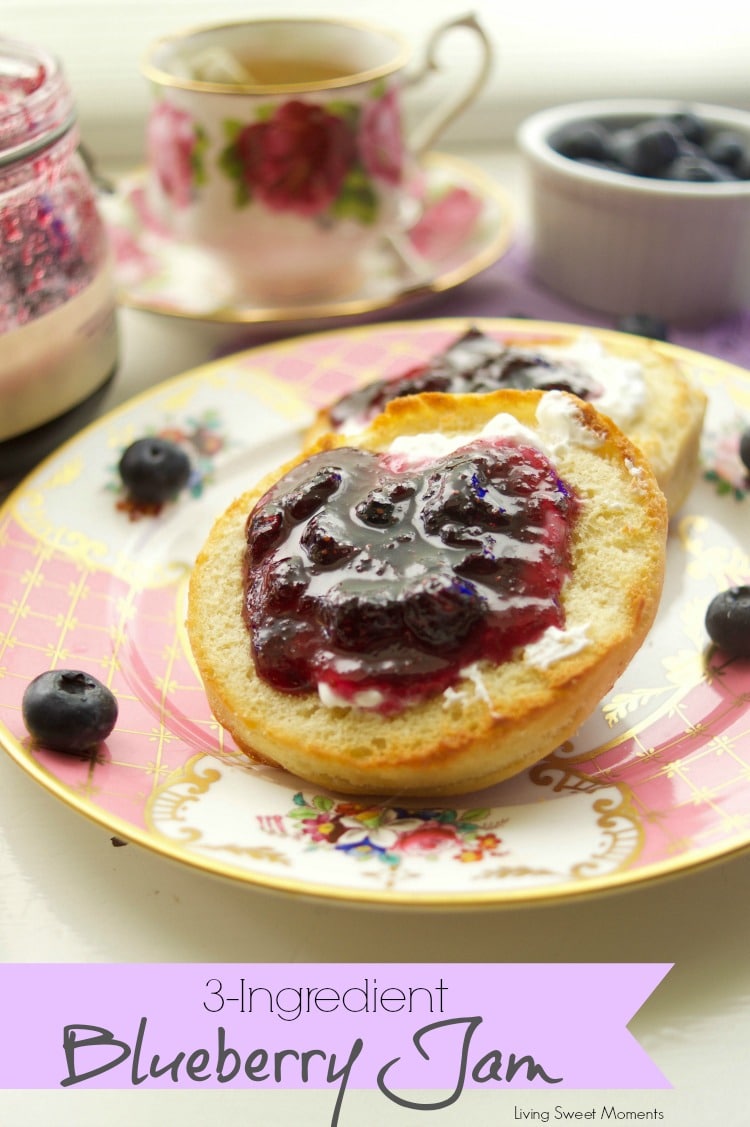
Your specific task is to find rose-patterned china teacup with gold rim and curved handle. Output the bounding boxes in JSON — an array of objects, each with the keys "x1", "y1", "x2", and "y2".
[{"x1": 143, "y1": 16, "x2": 492, "y2": 303}]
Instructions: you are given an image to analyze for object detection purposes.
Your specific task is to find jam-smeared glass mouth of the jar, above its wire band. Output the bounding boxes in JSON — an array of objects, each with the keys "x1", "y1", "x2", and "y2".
[{"x1": 0, "y1": 37, "x2": 76, "y2": 166}]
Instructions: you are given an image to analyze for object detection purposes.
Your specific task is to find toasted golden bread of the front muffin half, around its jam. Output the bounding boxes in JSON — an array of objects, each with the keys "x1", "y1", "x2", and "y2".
[{"x1": 187, "y1": 391, "x2": 668, "y2": 796}]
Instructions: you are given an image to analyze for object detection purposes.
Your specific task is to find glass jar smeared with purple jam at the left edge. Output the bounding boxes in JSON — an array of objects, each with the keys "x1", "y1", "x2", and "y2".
[{"x1": 0, "y1": 38, "x2": 117, "y2": 494}]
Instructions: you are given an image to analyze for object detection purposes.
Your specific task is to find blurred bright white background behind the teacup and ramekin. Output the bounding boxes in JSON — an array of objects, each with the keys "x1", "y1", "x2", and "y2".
[{"x1": 0, "y1": 0, "x2": 750, "y2": 165}]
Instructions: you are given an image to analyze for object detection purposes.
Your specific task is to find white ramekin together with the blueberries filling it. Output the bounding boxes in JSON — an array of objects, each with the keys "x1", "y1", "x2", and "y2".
[{"x1": 518, "y1": 98, "x2": 750, "y2": 326}]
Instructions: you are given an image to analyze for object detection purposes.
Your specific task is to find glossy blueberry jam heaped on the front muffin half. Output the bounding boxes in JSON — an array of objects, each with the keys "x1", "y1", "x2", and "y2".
[{"x1": 244, "y1": 437, "x2": 577, "y2": 713}]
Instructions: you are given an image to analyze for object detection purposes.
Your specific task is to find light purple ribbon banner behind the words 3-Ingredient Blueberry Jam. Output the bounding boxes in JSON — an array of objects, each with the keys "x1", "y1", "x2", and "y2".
[{"x1": 0, "y1": 964, "x2": 671, "y2": 1104}]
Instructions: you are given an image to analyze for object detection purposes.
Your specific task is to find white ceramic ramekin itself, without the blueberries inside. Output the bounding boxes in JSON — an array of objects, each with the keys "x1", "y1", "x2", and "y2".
[{"x1": 518, "y1": 99, "x2": 750, "y2": 323}]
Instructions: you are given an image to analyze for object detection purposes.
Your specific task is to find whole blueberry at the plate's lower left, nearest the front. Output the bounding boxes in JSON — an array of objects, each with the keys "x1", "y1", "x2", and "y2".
[{"x1": 21, "y1": 669, "x2": 117, "y2": 752}]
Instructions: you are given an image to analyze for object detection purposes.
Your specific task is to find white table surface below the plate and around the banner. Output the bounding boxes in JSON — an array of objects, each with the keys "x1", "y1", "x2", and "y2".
[{"x1": 0, "y1": 153, "x2": 750, "y2": 1127}]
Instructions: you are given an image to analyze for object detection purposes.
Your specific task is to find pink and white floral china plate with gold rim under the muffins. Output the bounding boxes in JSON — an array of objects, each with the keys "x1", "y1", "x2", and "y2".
[{"x1": 0, "y1": 319, "x2": 750, "y2": 907}]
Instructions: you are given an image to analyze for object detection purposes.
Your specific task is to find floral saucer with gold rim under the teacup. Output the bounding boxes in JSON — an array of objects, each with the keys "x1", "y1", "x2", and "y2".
[{"x1": 100, "y1": 152, "x2": 512, "y2": 325}]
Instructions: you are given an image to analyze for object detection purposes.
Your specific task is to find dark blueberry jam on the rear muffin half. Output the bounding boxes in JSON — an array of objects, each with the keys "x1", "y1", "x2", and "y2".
[{"x1": 329, "y1": 328, "x2": 602, "y2": 431}]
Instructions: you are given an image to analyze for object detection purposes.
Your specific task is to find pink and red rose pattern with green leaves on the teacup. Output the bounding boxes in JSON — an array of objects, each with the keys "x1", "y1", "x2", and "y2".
[{"x1": 148, "y1": 85, "x2": 405, "y2": 225}]
